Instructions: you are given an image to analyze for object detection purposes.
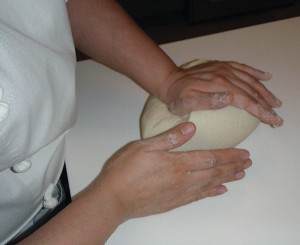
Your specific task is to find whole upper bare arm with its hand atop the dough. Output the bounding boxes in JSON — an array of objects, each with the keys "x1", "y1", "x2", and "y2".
[{"x1": 68, "y1": 0, "x2": 283, "y2": 126}]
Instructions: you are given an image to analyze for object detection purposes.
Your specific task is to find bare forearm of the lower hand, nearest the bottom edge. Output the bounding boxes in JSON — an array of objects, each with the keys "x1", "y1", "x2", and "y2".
[{"x1": 21, "y1": 187, "x2": 124, "y2": 245}]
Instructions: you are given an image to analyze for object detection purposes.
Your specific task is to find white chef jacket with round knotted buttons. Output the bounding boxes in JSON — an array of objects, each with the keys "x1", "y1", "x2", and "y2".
[{"x1": 0, "y1": 0, "x2": 76, "y2": 244}]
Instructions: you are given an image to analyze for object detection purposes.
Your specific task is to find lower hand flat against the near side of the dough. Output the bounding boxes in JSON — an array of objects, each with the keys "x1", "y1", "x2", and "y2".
[{"x1": 97, "y1": 123, "x2": 251, "y2": 221}]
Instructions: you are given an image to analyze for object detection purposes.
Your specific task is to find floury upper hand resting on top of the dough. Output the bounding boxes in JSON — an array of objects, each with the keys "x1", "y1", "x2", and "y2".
[{"x1": 160, "y1": 61, "x2": 283, "y2": 127}]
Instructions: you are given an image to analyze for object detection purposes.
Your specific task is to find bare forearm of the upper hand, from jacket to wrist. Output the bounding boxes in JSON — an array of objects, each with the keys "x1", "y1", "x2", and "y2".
[{"x1": 68, "y1": 0, "x2": 177, "y2": 100}]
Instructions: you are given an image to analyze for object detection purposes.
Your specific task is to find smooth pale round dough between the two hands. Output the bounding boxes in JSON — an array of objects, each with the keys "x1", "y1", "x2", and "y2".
[{"x1": 140, "y1": 60, "x2": 260, "y2": 151}]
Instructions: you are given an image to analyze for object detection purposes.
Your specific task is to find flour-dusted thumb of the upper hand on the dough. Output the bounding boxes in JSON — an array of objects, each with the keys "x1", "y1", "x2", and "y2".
[{"x1": 169, "y1": 91, "x2": 234, "y2": 116}]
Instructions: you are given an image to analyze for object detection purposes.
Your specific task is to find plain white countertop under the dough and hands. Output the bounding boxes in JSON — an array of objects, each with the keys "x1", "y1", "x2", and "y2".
[{"x1": 67, "y1": 17, "x2": 300, "y2": 245}]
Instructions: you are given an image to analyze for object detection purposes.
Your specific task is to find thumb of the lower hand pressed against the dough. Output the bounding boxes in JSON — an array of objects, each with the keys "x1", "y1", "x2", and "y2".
[{"x1": 146, "y1": 122, "x2": 196, "y2": 151}]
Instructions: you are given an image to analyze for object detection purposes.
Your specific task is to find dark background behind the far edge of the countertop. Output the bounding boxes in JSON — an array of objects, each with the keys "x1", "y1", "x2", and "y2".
[{"x1": 77, "y1": 0, "x2": 300, "y2": 60}]
